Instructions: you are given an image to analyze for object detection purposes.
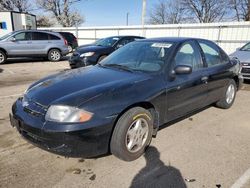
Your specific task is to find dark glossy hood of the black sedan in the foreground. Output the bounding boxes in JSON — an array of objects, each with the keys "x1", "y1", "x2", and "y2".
[{"x1": 25, "y1": 66, "x2": 148, "y2": 106}]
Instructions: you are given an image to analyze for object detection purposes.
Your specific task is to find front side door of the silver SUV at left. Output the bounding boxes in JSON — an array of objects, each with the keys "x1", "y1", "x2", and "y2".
[{"x1": 6, "y1": 32, "x2": 32, "y2": 56}]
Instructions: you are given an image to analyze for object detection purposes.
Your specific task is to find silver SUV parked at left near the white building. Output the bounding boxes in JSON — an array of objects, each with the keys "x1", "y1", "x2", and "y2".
[{"x1": 0, "y1": 30, "x2": 69, "y2": 64}]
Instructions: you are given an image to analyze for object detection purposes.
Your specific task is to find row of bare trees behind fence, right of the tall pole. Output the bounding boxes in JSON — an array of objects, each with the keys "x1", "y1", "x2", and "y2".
[{"x1": 148, "y1": 0, "x2": 250, "y2": 24}]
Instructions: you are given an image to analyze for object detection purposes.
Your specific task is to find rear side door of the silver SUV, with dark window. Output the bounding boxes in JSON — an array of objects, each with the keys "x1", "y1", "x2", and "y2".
[{"x1": 32, "y1": 32, "x2": 49, "y2": 55}]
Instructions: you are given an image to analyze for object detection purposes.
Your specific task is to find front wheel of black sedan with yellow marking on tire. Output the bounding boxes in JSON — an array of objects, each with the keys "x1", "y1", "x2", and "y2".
[{"x1": 110, "y1": 107, "x2": 153, "y2": 161}]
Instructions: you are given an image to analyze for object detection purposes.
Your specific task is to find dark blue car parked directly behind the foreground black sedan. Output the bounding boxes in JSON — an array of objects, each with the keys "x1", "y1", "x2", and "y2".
[{"x1": 69, "y1": 36, "x2": 144, "y2": 68}]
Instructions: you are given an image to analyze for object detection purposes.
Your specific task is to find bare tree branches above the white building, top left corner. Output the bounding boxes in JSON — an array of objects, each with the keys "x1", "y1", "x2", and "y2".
[{"x1": 0, "y1": 0, "x2": 31, "y2": 12}]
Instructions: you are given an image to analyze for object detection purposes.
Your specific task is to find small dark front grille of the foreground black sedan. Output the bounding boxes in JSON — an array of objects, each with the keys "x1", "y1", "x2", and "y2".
[{"x1": 22, "y1": 97, "x2": 47, "y2": 116}]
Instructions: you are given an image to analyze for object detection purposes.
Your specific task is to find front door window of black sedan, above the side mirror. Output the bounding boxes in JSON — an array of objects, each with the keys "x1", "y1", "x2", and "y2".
[{"x1": 174, "y1": 42, "x2": 203, "y2": 71}]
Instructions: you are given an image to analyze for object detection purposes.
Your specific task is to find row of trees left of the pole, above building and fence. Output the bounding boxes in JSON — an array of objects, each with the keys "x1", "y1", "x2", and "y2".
[{"x1": 0, "y1": 0, "x2": 84, "y2": 27}]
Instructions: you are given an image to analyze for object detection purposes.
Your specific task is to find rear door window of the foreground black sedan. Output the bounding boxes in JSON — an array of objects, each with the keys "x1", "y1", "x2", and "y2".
[{"x1": 199, "y1": 41, "x2": 226, "y2": 67}]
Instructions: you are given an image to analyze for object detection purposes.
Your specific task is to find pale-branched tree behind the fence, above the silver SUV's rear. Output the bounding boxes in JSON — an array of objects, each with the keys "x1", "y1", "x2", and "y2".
[{"x1": 37, "y1": 0, "x2": 84, "y2": 27}]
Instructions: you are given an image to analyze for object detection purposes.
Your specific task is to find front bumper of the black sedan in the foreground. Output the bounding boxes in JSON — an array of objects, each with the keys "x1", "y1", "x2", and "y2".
[{"x1": 10, "y1": 100, "x2": 114, "y2": 157}]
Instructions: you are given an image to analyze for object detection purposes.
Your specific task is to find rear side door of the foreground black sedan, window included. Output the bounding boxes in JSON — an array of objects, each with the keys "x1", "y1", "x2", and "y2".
[{"x1": 198, "y1": 40, "x2": 234, "y2": 103}]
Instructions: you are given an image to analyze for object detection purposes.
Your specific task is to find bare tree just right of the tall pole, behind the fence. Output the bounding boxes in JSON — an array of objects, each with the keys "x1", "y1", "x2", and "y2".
[{"x1": 149, "y1": 0, "x2": 184, "y2": 24}]
